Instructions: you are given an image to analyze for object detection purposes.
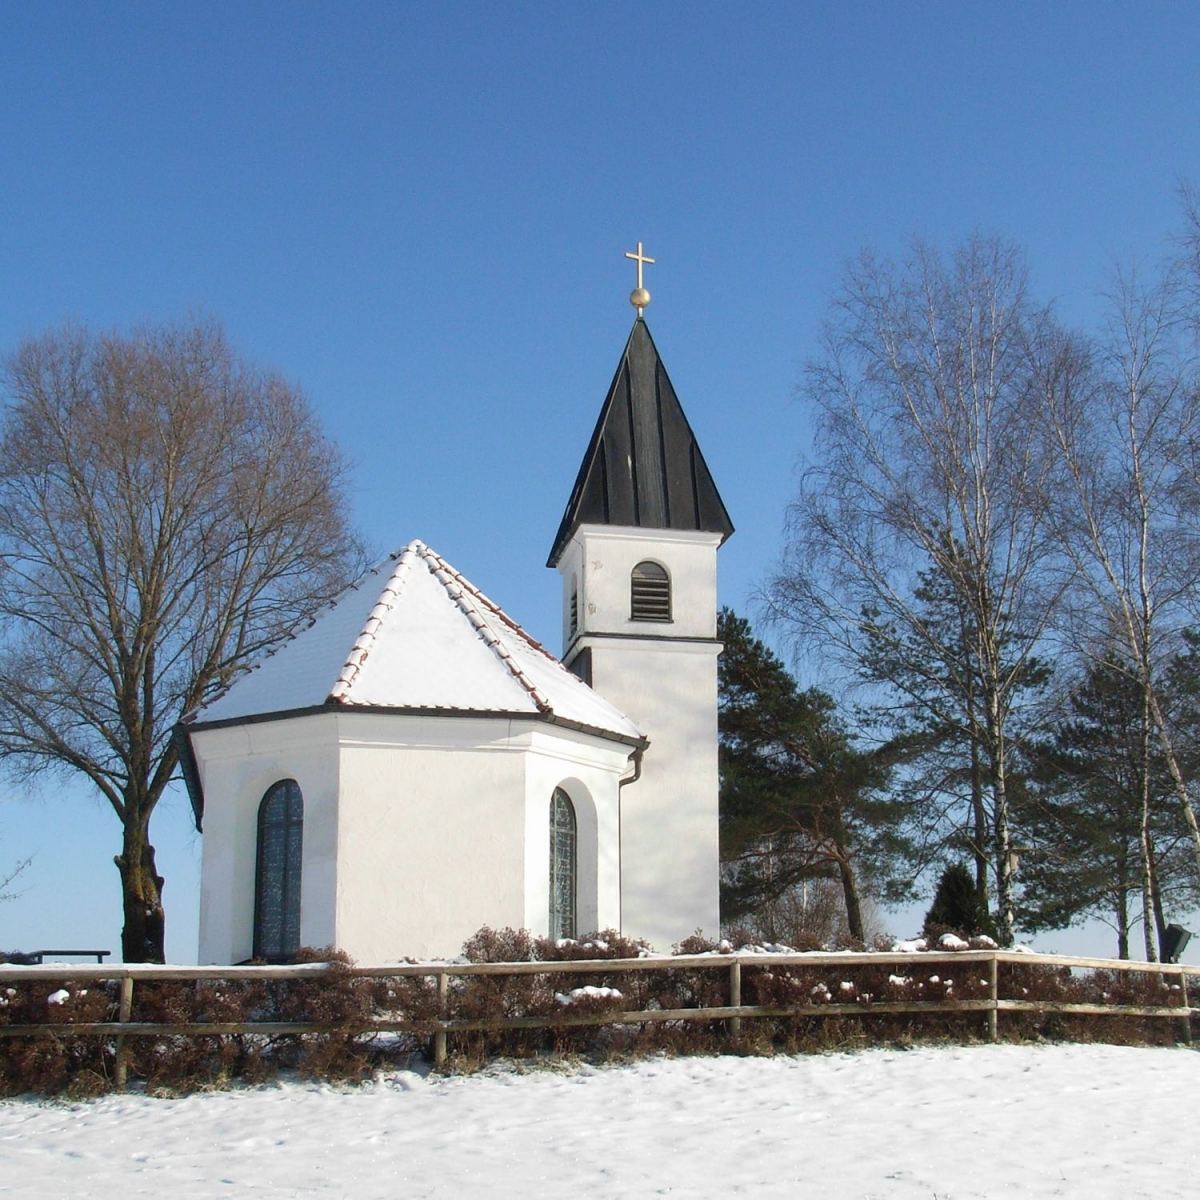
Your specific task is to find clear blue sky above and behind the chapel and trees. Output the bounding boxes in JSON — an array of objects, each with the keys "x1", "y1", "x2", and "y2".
[{"x1": 0, "y1": 0, "x2": 1200, "y2": 961}]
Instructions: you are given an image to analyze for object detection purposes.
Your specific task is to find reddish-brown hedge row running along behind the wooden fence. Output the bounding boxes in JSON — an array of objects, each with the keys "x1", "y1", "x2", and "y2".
[{"x1": 0, "y1": 929, "x2": 1184, "y2": 1097}]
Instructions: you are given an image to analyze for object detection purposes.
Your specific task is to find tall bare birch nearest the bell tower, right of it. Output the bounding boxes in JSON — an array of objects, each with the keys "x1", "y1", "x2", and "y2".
[{"x1": 772, "y1": 236, "x2": 1060, "y2": 938}]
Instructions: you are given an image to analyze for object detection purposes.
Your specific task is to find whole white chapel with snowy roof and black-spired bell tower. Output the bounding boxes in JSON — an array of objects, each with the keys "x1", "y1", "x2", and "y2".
[{"x1": 178, "y1": 265, "x2": 733, "y2": 964}]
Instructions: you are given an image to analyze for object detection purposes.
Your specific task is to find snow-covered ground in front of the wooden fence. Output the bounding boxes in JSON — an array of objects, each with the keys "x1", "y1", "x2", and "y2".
[{"x1": 0, "y1": 1045, "x2": 1200, "y2": 1200}]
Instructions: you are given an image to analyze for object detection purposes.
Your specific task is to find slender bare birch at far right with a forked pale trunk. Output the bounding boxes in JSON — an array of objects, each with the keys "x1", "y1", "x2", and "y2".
[{"x1": 1043, "y1": 275, "x2": 1200, "y2": 960}]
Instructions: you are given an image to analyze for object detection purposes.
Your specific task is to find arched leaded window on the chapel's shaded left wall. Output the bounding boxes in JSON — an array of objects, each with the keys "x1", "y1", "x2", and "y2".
[{"x1": 254, "y1": 779, "x2": 304, "y2": 962}]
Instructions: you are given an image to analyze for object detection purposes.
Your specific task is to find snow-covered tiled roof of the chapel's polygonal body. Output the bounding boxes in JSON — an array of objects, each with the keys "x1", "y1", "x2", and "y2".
[{"x1": 184, "y1": 541, "x2": 646, "y2": 745}]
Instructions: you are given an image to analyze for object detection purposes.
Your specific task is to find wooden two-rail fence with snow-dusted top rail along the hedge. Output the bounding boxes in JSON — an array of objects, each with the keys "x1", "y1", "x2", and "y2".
[{"x1": 0, "y1": 950, "x2": 1200, "y2": 1087}]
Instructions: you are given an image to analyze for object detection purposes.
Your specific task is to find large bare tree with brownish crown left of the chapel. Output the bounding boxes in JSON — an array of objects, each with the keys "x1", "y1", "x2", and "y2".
[{"x1": 0, "y1": 324, "x2": 360, "y2": 961}]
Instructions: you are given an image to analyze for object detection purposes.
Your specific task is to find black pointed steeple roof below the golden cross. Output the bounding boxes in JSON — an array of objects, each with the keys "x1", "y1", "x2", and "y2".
[{"x1": 546, "y1": 318, "x2": 733, "y2": 566}]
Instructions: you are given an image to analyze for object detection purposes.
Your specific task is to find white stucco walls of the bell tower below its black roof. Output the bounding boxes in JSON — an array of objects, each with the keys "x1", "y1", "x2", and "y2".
[{"x1": 559, "y1": 526, "x2": 720, "y2": 949}]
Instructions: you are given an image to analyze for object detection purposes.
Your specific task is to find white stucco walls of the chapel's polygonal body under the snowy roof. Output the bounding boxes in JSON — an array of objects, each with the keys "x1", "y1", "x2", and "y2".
[{"x1": 193, "y1": 712, "x2": 630, "y2": 962}]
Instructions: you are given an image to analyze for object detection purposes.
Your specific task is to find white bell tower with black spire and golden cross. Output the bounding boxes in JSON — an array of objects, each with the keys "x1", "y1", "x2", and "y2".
[{"x1": 547, "y1": 242, "x2": 733, "y2": 949}]
